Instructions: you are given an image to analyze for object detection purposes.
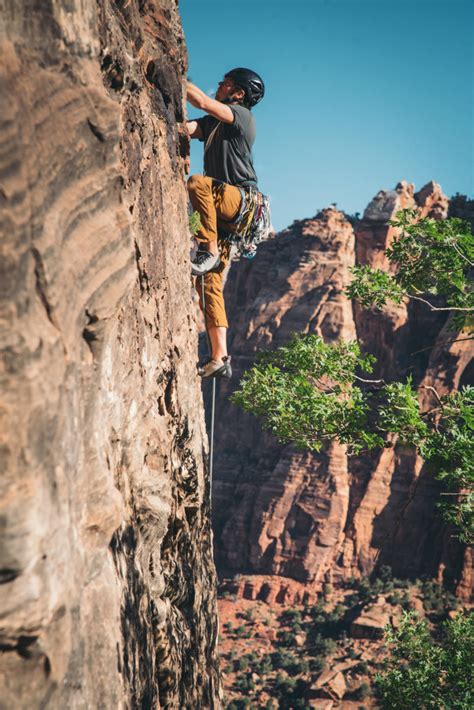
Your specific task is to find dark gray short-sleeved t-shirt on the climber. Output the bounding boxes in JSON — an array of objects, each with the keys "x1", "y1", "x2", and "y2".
[{"x1": 197, "y1": 104, "x2": 257, "y2": 185}]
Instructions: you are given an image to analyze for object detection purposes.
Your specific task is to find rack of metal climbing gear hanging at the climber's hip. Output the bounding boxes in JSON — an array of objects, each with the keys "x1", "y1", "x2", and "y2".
[{"x1": 222, "y1": 185, "x2": 272, "y2": 259}]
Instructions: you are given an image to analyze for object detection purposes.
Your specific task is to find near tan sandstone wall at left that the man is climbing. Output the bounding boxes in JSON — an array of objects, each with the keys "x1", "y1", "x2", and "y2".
[{"x1": 0, "y1": 0, "x2": 219, "y2": 708}]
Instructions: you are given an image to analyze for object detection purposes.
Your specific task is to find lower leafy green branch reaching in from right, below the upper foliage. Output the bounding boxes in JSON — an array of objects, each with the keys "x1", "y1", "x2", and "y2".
[{"x1": 231, "y1": 335, "x2": 474, "y2": 541}]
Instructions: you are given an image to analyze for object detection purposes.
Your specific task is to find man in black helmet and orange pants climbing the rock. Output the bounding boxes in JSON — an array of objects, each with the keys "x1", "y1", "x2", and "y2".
[{"x1": 186, "y1": 68, "x2": 265, "y2": 378}]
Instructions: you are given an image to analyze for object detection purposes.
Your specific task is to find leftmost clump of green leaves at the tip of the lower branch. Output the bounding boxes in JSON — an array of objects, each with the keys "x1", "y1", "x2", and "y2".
[{"x1": 232, "y1": 335, "x2": 383, "y2": 451}]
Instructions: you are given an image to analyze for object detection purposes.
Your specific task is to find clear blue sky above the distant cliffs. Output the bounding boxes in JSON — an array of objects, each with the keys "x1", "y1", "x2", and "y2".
[{"x1": 179, "y1": 0, "x2": 474, "y2": 230}]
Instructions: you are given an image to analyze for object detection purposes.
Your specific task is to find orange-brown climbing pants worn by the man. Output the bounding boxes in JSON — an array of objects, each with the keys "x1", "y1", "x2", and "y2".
[{"x1": 188, "y1": 175, "x2": 242, "y2": 328}]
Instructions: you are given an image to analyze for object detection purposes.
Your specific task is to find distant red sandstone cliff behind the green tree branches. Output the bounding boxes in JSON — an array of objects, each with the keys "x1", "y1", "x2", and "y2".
[{"x1": 214, "y1": 183, "x2": 472, "y2": 599}]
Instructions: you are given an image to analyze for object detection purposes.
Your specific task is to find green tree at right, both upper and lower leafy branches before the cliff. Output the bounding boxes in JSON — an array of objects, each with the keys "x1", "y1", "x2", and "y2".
[{"x1": 232, "y1": 210, "x2": 474, "y2": 542}]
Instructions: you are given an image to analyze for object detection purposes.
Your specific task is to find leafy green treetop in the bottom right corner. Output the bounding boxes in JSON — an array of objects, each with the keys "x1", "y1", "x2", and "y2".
[{"x1": 375, "y1": 612, "x2": 474, "y2": 710}]
